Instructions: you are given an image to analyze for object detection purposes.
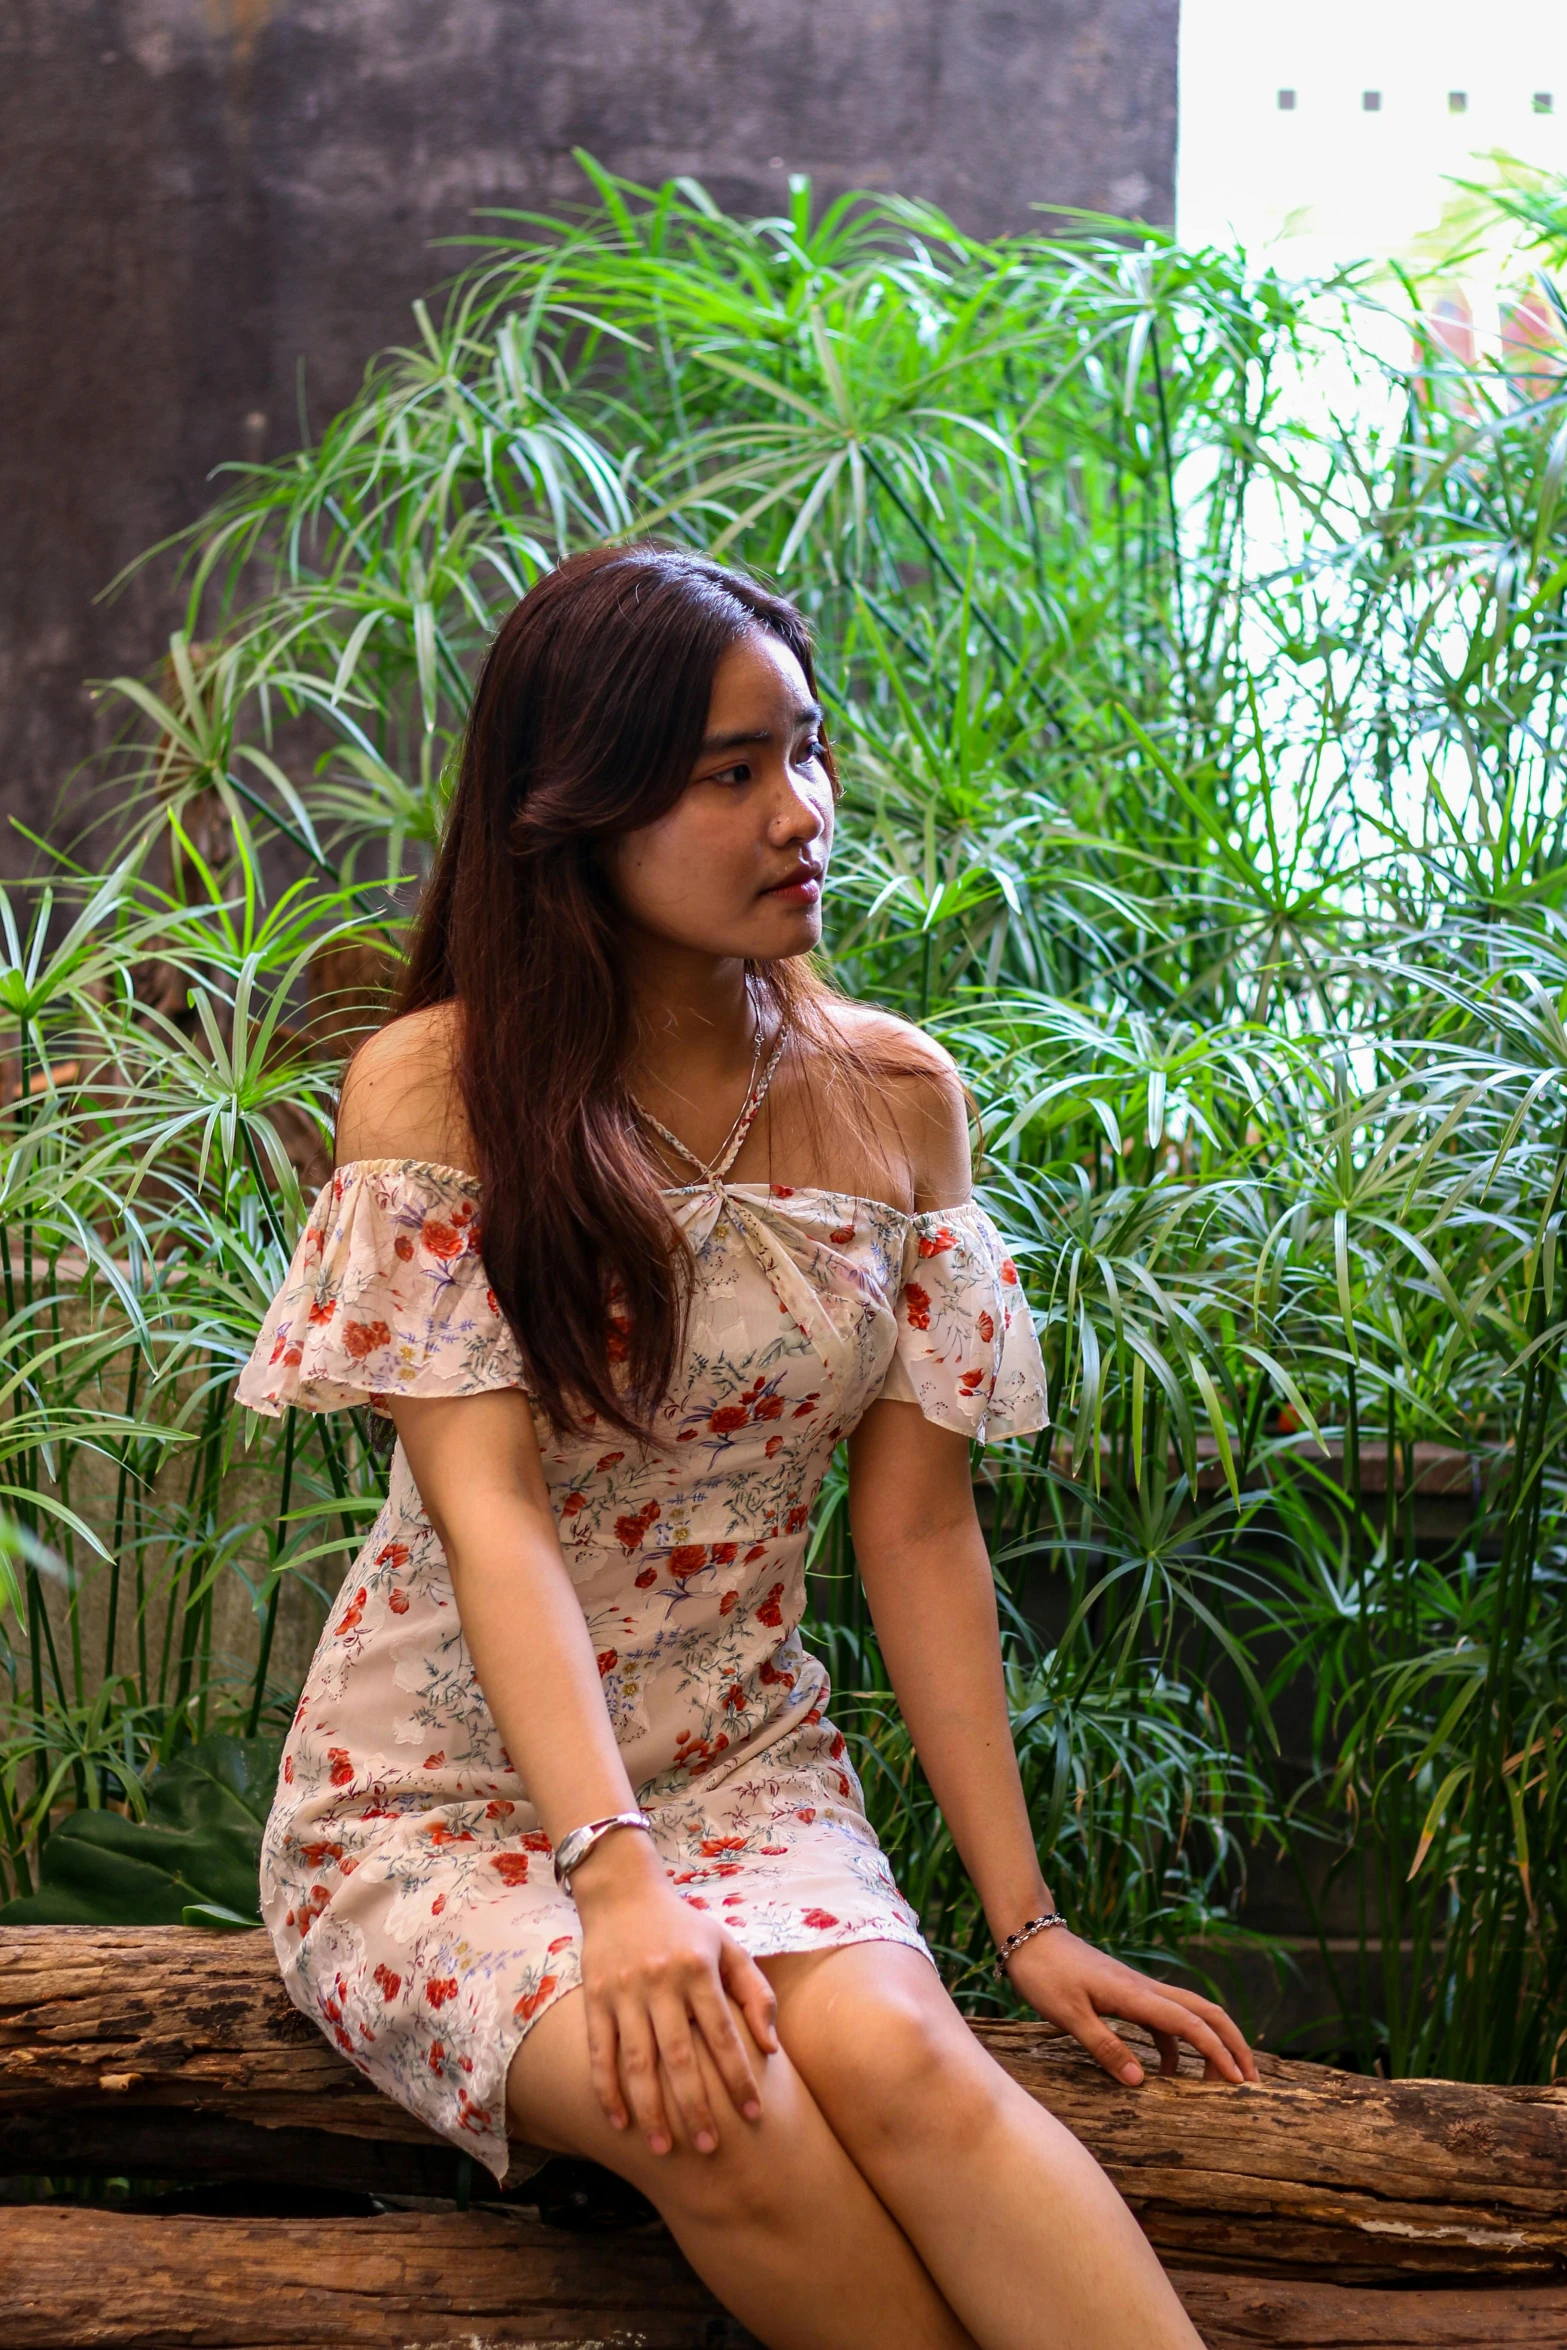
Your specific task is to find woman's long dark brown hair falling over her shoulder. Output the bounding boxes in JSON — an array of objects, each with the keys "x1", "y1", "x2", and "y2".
[{"x1": 399, "y1": 543, "x2": 836, "y2": 1436}]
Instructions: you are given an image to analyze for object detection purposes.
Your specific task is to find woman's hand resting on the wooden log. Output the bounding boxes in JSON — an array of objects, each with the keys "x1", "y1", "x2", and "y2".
[{"x1": 1008, "y1": 1927, "x2": 1257, "y2": 2089}]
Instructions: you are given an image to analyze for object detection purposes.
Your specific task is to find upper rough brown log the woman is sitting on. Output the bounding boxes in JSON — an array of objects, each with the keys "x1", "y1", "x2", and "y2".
[{"x1": 0, "y1": 1927, "x2": 1567, "y2": 2282}]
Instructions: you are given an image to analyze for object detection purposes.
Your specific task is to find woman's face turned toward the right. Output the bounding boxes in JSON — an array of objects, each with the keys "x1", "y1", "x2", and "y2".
[{"x1": 608, "y1": 630, "x2": 832, "y2": 961}]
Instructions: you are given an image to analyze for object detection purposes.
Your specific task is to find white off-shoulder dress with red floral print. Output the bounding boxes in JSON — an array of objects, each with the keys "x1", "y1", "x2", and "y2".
[{"x1": 240, "y1": 1069, "x2": 1045, "y2": 2178}]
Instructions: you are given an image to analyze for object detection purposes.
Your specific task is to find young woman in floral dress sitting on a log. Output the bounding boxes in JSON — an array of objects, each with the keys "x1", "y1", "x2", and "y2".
[{"x1": 240, "y1": 545, "x2": 1255, "y2": 2350}]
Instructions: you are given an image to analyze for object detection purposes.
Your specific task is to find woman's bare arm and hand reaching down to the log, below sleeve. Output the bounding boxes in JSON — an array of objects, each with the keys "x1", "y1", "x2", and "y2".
[{"x1": 848, "y1": 1398, "x2": 1257, "y2": 2084}]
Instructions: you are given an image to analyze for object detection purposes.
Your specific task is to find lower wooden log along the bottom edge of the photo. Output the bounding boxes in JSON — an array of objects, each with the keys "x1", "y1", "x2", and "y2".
[{"x1": 0, "y1": 2204, "x2": 1567, "y2": 2350}]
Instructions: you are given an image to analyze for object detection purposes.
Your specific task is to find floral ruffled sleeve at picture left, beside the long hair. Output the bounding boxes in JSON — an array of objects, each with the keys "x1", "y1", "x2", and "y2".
[{"x1": 237, "y1": 1159, "x2": 524, "y2": 1415}]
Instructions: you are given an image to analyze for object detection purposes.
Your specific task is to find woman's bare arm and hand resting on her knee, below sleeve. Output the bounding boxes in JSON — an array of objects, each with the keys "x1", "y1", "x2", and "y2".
[{"x1": 392, "y1": 1389, "x2": 778, "y2": 2153}]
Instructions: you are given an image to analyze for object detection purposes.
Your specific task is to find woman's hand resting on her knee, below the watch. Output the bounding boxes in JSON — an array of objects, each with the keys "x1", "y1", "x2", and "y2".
[{"x1": 571, "y1": 1831, "x2": 778, "y2": 2155}]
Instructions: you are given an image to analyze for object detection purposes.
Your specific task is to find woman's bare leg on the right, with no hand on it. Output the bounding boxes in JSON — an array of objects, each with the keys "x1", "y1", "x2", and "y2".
[{"x1": 761, "y1": 1943, "x2": 1201, "y2": 2350}]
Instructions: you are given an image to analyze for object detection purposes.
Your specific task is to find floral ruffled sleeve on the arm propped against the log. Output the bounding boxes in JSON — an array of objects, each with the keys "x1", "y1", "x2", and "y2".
[{"x1": 881, "y1": 1201, "x2": 1050, "y2": 1443}]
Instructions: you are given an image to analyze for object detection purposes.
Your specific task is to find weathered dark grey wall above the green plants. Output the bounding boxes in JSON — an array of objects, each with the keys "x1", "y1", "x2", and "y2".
[{"x1": 0, "y1": 0, "x2": 1179, "y2": 872}]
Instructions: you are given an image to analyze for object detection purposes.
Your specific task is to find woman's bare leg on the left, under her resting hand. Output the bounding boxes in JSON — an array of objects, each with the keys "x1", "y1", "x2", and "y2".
[{"x1": 507, "y1": 1998, "x2": 973, "y2": 2350}]
